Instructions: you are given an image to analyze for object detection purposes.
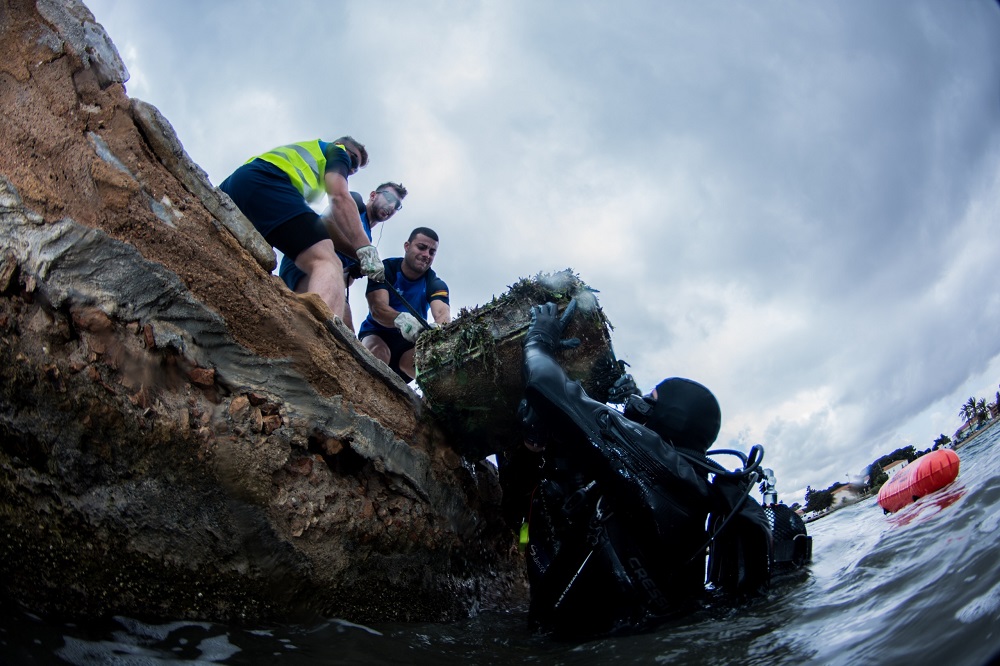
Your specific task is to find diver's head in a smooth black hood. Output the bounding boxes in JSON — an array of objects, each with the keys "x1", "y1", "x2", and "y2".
[{"x1": 626, "y1": 377, "x2": 722, "y2": 453}]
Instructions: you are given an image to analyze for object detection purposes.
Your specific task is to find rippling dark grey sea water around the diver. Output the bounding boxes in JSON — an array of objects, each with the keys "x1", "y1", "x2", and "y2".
[{"x1": 0, "y1": 427, "x2": 1000, "y2": 666}]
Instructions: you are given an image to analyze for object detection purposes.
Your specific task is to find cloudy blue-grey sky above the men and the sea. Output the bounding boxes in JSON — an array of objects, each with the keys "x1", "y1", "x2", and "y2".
[{"x1": 86, "y1": 0, "x2": 1000, "y2": 503}]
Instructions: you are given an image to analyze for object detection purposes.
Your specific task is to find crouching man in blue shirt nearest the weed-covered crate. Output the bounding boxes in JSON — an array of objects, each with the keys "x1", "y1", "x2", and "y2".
[{"x1": 358, "y1": 227, "x2": 451, "y2": 382}]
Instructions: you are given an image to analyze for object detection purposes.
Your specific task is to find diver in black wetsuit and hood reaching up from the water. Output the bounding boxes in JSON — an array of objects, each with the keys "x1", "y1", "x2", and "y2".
[{"x1": 500, "y1": 301, "x2": 771, "y2": 637}]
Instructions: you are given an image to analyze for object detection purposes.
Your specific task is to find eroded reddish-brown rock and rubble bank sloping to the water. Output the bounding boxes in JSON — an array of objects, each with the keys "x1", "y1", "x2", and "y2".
[{"x1": 0, "y1": 0, "x2": 526, "y2": 622}]
